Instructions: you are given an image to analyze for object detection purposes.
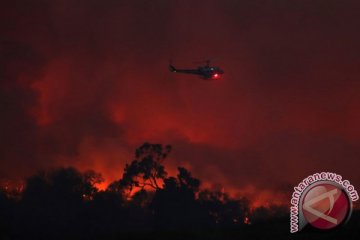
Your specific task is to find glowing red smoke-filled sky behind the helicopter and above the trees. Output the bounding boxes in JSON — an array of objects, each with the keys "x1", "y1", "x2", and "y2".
[{"x1": 0, "y1": 0, "x2": 360, "y2": 206}]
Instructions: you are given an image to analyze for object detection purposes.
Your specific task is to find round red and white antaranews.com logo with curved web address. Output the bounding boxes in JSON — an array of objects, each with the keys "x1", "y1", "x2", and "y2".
[{"x1": 290, "y1": 172, "x2": 359, "y2": 233}]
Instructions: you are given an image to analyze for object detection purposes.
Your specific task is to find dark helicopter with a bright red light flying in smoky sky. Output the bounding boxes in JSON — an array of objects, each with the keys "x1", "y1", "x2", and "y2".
[{"x1": 169, "y1": 60, "x2": 224, "y2": 80}]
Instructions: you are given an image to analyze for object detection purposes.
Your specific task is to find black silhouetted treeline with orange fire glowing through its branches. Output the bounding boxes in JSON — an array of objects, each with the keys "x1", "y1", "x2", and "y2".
[{"x1": 0, "y1": 143, "x2": 287, "y2": 239}]
